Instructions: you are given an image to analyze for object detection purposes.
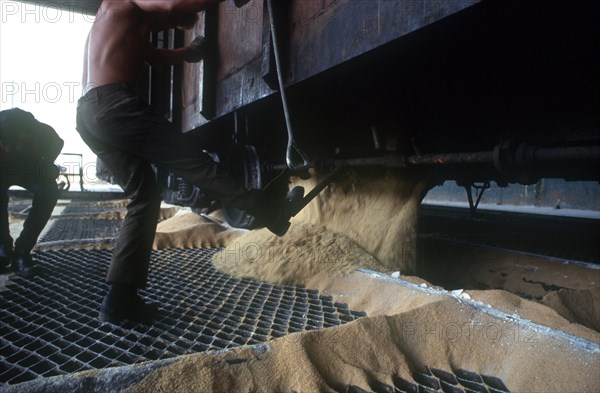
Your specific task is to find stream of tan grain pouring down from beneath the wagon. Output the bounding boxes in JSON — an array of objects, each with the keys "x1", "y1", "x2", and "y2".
[{"x1": 294, "y1": 170, "x2": 427, "y2": 274}]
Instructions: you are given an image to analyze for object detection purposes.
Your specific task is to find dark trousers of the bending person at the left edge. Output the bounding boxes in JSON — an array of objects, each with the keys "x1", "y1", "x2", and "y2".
[{"x1": 0, "y1": 163, "x2": 58, "y2": 253}]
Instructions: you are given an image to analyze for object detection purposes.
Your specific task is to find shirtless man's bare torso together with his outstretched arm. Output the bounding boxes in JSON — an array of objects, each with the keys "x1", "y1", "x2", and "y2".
[{"x1": 83, "y1": 0, "x2": 222, "y2": 94}]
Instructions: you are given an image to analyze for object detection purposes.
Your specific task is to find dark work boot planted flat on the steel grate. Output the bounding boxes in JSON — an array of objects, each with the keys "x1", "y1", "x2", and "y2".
[{"x1": 98, "y1": 283, "x2": 158, "y2": 323}]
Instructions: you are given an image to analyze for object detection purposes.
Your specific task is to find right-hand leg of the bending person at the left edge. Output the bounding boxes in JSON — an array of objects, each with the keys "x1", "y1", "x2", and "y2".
[{"x1": 12, "y1": 177, "x2": 58, "y2": 277}]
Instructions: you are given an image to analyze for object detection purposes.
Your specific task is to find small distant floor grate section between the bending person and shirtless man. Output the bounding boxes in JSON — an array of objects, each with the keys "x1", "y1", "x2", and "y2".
[{"x1": 39, "y1": 218, "x2": 123, "y2": 243}]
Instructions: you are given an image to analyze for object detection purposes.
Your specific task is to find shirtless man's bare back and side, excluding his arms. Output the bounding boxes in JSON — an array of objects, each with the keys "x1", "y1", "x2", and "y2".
[{"x1": 83, "y1": 0, "x2": 152, "y2": 93}]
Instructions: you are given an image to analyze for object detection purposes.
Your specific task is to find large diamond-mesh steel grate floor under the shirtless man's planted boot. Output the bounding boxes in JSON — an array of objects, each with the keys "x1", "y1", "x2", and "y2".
[{"x1": 0, "y1": 249, "x2": 365, "y2": 385}]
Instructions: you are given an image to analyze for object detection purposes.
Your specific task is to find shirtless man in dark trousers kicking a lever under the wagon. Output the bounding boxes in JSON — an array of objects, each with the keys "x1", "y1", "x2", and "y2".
[{"x1": 77, "y1": 0, "x2": 304, "y2": 323}]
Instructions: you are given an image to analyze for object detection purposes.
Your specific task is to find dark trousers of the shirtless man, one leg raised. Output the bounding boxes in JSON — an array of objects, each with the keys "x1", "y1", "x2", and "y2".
[{"x1": 77, "y1": 84, "x2": 251, "y2": 288}]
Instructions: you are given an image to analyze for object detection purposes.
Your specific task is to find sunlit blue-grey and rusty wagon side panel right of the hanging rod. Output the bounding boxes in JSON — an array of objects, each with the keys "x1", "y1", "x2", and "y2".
[{"x1": 290, "y1": 0, "x2": 479, "y2": 82}]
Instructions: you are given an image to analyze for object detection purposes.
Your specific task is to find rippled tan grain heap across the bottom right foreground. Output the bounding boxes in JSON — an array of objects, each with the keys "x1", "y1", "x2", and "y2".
[{"x1": 122, "y1": 273, "x2": 600, "y2": 392}]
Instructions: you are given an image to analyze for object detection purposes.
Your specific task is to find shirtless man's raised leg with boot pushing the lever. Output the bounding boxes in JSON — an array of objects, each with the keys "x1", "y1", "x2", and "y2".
[{"x1": 92, "y1": 99, "x2": 304, "y2": 236}]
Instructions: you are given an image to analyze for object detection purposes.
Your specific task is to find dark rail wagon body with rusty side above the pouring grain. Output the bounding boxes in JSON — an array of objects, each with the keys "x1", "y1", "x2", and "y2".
[{"x1": 22, "y1": 0, "x2": 600, "y2": 201}]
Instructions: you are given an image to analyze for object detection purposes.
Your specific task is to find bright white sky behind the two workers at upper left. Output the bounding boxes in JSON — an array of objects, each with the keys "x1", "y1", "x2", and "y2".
[{"x1": 0, "y1": 0, "x2": 96, "y2": 185}]
